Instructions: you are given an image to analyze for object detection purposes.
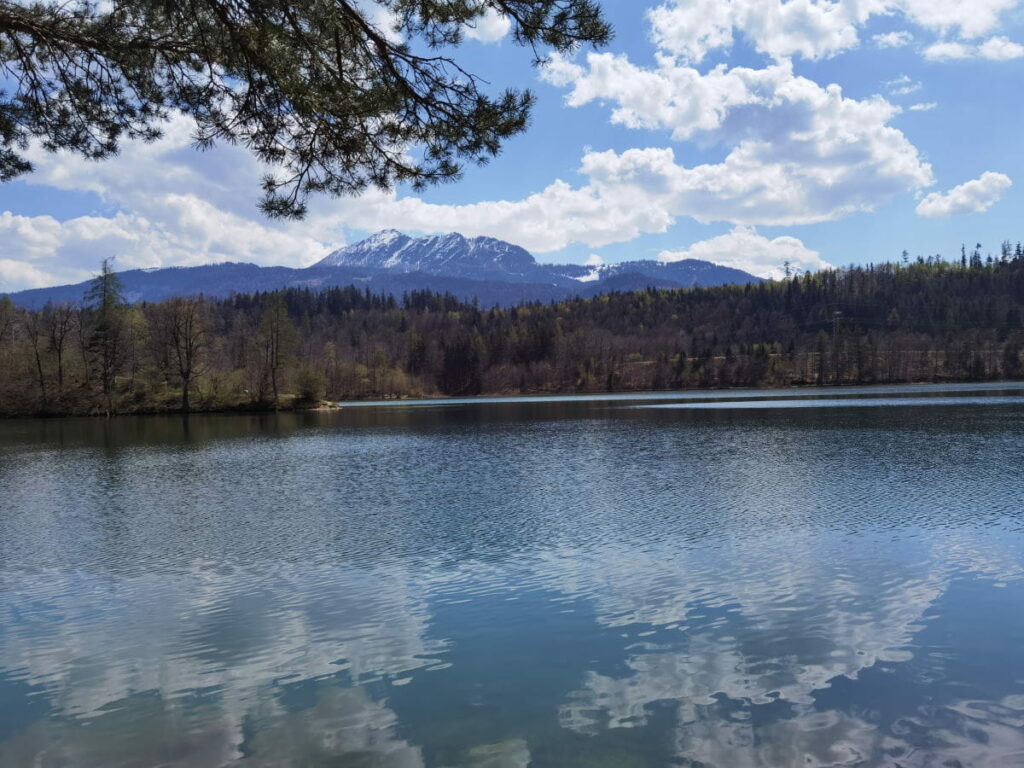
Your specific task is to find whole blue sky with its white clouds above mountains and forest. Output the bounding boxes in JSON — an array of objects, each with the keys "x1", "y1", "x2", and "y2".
[{"x1": 0, "y1": 0, "x2": 1024, "y2": 291}]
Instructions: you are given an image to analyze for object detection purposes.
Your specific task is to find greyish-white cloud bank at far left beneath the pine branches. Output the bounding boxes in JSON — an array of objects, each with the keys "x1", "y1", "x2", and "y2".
[{"x1": 0, "y1": 117, "x2": 338, "y2": 290}]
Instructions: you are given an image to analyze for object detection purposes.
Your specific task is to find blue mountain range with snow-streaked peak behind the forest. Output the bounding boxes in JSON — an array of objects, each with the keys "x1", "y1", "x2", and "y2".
[{"x1": 4, "y1": 229, "x2": 761, "y2": 307}]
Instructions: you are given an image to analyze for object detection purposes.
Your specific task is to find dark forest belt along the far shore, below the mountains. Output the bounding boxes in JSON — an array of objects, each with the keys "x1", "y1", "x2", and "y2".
[{"x1": 0, "y1": 243, "x2": 1024, "y2": 415}]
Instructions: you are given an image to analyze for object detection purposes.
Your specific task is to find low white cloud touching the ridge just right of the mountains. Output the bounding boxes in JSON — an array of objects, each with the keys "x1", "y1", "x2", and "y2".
[{"x1": 658, "y1": 226, "x2": 833, "y2": 278}]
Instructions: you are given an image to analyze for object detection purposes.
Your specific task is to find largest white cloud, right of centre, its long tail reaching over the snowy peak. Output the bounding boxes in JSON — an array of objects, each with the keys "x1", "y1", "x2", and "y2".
[{"x1": 258, "y1": 54, "x2": 932, "y2": 253}]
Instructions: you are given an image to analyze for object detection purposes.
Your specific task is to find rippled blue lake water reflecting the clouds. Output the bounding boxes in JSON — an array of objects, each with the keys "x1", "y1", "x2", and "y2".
[{"x1": 0, "y1": 385, "x2": 1024, "y2": 768}]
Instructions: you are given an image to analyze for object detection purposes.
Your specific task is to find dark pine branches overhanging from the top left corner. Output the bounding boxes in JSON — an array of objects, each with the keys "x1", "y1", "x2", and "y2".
[{"x1": 0, "y1": 0, "x2": 610, "y2": 217}]
